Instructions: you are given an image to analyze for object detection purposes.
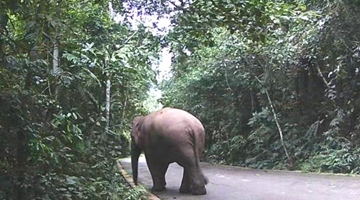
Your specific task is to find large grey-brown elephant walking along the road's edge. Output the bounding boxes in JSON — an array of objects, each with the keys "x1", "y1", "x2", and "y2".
[{"x1": 131, "y1": 108, "x2": 208, "y2": 195}]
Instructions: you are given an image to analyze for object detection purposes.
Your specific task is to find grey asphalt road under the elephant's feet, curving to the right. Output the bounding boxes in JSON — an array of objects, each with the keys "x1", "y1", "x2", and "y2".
[{"x1": 120, "y1": 157, "x2": 360, "y2": 200}]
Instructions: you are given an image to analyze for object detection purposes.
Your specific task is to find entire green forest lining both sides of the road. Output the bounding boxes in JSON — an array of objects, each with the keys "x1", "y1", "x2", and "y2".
[{"x1": 0, "y1": 0, "x2": 360, "y2": 200}]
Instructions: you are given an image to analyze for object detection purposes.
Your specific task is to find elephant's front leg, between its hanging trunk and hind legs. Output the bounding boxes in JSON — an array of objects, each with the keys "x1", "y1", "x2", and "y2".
[{"x1": 146, "y1": 156, "x2": 169, "y2": 192}]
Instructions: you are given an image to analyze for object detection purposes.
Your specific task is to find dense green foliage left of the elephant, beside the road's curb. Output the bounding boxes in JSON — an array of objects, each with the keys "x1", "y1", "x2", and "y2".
[{"x1": 0, "y1": 0, "x2": 159, "y2": 200}]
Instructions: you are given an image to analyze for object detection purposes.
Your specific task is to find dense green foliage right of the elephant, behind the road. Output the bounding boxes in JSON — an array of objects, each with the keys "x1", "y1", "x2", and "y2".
[{"x1": 158, "y1": 0, "x2": 360, "y2": 173}]
